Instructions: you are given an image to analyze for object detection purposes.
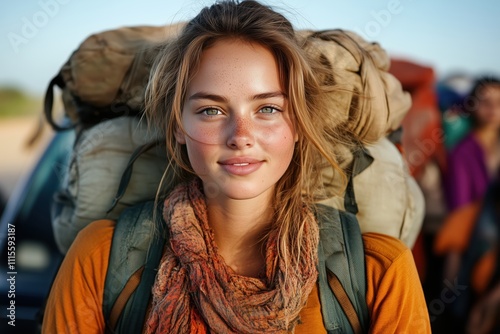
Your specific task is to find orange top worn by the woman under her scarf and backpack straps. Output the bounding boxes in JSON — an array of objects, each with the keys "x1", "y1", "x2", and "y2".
[{"x1": 42, "y1": 220, "x2": 431, "y2": 334}]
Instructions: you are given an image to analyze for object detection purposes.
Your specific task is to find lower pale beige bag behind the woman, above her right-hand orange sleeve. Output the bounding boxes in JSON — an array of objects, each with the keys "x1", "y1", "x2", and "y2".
[{"x1": 320, "y1": 137, "x2": 425, "y2": 248}]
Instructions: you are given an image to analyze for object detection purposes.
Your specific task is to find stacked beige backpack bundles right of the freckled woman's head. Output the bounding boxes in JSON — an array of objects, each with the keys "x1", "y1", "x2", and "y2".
[{"x1": 299, "y1": 30, "x2": 425, "y2": 247}]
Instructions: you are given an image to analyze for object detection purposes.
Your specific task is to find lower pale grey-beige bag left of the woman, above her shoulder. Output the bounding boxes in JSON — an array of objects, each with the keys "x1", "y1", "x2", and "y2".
[{"x1": 52, "y1": 117, "x2": 167, "y2": 253}]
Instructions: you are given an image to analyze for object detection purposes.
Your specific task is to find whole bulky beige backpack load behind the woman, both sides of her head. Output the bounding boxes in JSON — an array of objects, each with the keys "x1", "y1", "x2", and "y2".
[{"x1": 44, "y1": 23, "x2": 422, "y2": 253}]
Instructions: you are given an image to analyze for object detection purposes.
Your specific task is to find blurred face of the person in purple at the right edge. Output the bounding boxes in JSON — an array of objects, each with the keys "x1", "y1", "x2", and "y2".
[{"x1": 476, "y1": 85, "x2": 500, "y2": 129}]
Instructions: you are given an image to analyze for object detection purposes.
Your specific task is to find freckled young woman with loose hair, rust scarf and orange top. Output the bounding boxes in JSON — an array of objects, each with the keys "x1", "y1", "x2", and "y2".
[{"x1": 43, "y1": 1, "x2": 430, "y2": 333}]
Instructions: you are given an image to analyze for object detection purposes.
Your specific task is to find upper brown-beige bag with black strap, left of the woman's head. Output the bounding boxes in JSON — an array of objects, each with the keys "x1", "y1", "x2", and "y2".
[{"x1": 44, "y1": 23, "x2": 184, "y2": 130}]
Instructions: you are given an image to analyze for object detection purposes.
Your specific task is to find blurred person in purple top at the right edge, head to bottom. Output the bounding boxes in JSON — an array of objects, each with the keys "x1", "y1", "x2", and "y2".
[{"x1": 435, "y1": 77, "x2": 500, "y2": 333}]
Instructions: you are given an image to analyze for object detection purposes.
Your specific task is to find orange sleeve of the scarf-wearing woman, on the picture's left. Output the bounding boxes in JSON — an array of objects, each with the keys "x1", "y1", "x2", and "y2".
[{"x1": 42, "y1": 220, "x2": 115, "y2": 334}]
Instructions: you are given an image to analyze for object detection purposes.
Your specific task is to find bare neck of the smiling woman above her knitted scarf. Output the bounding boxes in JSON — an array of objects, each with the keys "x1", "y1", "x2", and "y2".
[{"x1": 207, "y1": 196, "x2": 273, "y2": 277}]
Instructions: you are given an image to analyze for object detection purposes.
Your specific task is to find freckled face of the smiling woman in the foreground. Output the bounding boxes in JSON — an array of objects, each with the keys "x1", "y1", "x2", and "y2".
[{"x1": 176, "y1": 39, "x2": 297, "y2": 200}]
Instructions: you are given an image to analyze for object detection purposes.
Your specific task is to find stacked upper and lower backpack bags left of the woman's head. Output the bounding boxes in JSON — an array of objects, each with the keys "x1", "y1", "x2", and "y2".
[{"x1": 44, "y1": 24, "x2": 182, "y2": 254}]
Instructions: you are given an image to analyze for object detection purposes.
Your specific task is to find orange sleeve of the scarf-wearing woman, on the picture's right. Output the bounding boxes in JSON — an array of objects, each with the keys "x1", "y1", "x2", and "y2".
[{"x1": 363, "y1": 233, "x2": 431, "y2": 334}]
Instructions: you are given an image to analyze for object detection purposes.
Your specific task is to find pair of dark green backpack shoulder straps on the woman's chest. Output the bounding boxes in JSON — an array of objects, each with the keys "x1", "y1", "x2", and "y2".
[{"x1": 102, "y1": 202, "x2": 369, "y2": 334}]
